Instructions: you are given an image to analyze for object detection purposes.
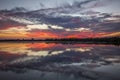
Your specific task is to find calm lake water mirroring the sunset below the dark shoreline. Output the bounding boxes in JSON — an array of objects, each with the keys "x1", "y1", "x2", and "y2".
[{"x1": 0, "y1": 42, "x2": 120, "y2": 80}]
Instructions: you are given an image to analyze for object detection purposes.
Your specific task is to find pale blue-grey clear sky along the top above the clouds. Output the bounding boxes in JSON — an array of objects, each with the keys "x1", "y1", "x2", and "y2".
[{"x1": 0, "y1": 0, "x2": 120, "y2": 12}]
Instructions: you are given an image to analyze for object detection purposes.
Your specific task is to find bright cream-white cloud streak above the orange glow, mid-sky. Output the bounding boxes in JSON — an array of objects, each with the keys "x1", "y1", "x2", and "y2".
[{"x1": 26, "y1": 24, "x2": 92, "y2": 32}]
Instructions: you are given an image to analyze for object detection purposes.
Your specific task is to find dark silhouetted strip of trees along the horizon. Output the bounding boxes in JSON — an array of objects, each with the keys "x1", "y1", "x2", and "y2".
[{"x1": 0, "y1": 37, "x2": 120, "y2": 44}]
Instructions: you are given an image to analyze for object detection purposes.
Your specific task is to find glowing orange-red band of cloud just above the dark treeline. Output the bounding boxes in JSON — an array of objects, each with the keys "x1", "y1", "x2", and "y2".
[{"x1": 0, "y1": 27, "x2": 120, "y2": 39}]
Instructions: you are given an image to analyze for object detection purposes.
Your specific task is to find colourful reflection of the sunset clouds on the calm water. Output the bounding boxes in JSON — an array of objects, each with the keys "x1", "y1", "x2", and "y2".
[{"x1": 0, "y1": 42, "x2": 120, "y2": 79}]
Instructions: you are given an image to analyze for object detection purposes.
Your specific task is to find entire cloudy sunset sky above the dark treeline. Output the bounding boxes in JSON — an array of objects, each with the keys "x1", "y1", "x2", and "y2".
[{"x1": 0, "y1": 0, "x2": 120, "y2": 39}]
